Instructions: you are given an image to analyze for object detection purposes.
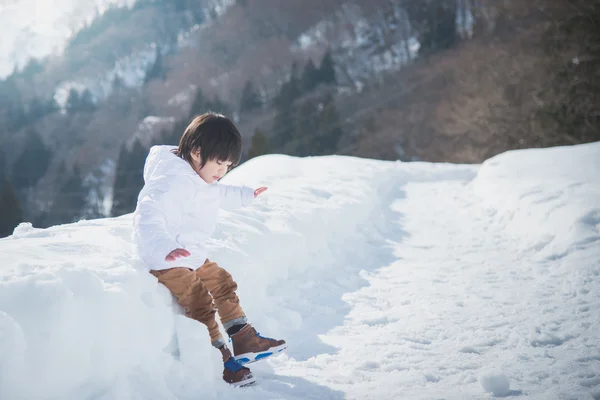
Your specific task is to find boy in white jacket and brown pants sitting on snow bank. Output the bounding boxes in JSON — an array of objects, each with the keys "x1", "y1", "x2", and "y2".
[{"x1": 134, "y1": 113, "x2": 287, "y2": 386}]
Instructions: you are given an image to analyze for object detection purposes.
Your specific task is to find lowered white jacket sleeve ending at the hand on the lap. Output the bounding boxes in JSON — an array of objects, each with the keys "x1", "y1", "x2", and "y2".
[{"x1": 134, "y1": 178, "x2": 185, "y2": 266}]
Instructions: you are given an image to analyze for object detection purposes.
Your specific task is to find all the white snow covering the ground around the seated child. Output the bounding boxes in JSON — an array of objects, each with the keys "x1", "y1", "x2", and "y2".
[{"x1": 0, "y1": 143, "x2": 600, "y2": 400}]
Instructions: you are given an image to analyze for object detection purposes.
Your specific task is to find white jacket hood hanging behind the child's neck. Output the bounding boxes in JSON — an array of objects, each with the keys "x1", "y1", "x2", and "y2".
[{"x1": 144, "y1": 145, "x2": 198, "y2": 182}]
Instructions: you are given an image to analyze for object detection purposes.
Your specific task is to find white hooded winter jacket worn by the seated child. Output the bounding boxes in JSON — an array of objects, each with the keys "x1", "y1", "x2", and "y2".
[{"x1": 133, "y1": 146, "x2": 254, "y2": 270}]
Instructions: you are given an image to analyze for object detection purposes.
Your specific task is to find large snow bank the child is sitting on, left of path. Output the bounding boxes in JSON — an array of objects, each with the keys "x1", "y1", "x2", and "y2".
[{"x1": 0, "y1": 156, "x2": 393, "y2": 400}]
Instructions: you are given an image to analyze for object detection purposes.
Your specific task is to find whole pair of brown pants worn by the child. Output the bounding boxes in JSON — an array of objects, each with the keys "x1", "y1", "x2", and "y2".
[{"x1": 150, "y1": 260, "x2": 245, "y2": 347}]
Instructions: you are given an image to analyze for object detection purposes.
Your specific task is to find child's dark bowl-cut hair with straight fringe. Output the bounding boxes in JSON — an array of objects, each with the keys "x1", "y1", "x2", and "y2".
[{"x1": 175, "y1": 112, "x2": 242, "y2": 168}]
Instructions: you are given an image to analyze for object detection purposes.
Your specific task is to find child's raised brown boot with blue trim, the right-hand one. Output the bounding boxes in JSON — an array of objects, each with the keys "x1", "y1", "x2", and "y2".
[{"x1": 231, "y1": 324, "x2": 287, "y2": 364}]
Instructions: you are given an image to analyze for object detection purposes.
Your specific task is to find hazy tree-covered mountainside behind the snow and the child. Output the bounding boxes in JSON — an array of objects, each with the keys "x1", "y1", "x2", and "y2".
[{"x1": 0, "y1": 0, "x2": 600, "y2": 236}]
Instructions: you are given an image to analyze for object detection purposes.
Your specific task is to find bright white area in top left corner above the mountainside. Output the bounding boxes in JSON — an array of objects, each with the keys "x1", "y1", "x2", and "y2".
[{"x1": 0, "y1": 0, "x2": 135, "y2": 79}]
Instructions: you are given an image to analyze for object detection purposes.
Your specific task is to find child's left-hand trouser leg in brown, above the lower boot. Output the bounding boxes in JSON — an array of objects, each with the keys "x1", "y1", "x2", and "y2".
[{"x1": 150, "y1": 268, "x2": 225, "y2": 348}]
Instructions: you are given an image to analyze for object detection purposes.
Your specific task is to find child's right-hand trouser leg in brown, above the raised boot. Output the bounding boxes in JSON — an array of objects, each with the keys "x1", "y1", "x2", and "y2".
[{"x1": 195, "y1": 260, "x2": 247, "y2": 330}]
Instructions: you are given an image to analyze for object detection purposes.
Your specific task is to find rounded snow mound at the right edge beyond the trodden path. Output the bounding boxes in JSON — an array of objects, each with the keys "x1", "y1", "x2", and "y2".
[{"x1": 473, "y1": 143, "x2": 600, "y2": 258}]
